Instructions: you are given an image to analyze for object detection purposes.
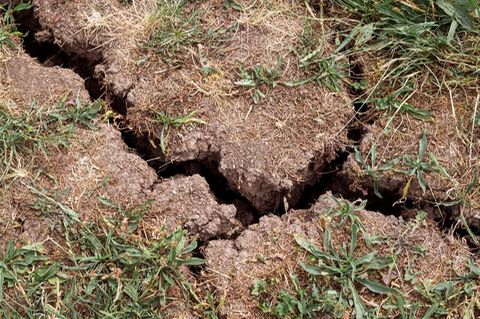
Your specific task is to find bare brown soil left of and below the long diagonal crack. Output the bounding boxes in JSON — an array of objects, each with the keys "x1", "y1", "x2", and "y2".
[{"x1": 1, "y1": 51, "x2": 240, "y2": 248}]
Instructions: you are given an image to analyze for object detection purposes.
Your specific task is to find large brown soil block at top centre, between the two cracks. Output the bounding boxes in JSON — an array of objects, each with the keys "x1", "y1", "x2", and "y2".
[{"x1": 28, "y1": 1, "x2": 353, "y2": 211}]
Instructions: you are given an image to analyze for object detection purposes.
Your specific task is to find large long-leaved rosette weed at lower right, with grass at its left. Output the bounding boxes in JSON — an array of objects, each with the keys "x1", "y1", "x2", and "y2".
[{"x1": 252, "y1": 200, "x2": 399, "y2": 319}]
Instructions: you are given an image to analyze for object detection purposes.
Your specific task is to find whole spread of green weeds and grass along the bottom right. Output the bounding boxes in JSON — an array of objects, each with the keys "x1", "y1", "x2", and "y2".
[{"x1": 251, "y1": 200, "x2": 480, "y2": 319}]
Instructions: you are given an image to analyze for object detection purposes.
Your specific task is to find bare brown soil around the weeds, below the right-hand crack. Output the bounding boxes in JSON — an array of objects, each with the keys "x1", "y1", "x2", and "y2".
[{"x1": 203, "y1": 194, "x2": 469, "y2": 318}]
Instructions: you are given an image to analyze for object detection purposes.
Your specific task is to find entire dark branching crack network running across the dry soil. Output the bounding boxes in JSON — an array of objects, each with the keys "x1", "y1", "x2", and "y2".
[{"x1": 13, "y1": 9, "x2": 480, "y2": 250}]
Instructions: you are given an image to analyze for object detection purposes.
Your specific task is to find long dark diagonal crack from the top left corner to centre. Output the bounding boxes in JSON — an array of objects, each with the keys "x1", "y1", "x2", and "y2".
[{"x1": 16, "y1": 8, "x2": 261, "y2": 235}]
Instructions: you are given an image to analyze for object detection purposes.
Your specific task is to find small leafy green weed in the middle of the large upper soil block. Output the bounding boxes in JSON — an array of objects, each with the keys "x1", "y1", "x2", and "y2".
[{"x1": 235, "y1": 65, "x2": 280, "y2": 104}]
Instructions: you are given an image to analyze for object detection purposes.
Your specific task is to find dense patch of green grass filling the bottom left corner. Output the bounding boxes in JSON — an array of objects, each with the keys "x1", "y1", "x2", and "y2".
[{"x1": 0, "y1": 196, "x2": 203, "y2": 318}]
